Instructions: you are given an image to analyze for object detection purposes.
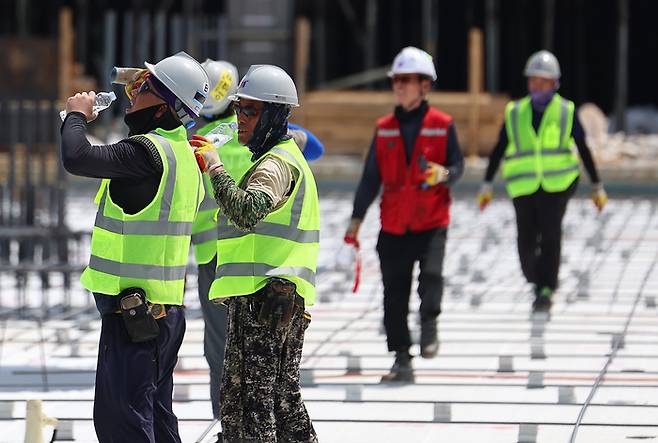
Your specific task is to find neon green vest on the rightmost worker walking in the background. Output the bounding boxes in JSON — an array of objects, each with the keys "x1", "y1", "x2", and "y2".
[{"x1": 503, "y1": 94, "x2": 580, "y2": 198}]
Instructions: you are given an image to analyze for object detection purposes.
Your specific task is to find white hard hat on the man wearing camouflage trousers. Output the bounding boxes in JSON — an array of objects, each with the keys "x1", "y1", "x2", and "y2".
[{"x1": 230, "y1": 65, "x2": 299, "y2": 107}]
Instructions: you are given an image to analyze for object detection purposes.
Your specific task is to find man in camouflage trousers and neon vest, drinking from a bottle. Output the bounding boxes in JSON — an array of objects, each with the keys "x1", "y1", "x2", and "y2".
[{"x1": 191, "y1": 65, "x2": 320, "y2": 443}]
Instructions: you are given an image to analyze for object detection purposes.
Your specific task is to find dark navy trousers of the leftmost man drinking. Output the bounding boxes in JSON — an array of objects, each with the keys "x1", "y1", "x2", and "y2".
[{"x1": 94, "y1": 306, "x2": 185, "y2": 443}]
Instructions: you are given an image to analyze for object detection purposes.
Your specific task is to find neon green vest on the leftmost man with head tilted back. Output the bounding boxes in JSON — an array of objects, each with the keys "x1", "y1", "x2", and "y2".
[{"x1": 80, "y1": 126, "x2": 204, "y2": 305}]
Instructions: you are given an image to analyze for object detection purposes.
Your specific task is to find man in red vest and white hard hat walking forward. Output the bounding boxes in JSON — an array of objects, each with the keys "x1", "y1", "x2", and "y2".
[{"x1": 345, "y1": 46, "x2": 464, "y2": 382}]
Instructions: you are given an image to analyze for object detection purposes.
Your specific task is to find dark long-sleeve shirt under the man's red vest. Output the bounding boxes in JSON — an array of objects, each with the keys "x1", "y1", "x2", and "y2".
[{"x1": 352, "y1": 102, "x2": 464, "y2": 219}]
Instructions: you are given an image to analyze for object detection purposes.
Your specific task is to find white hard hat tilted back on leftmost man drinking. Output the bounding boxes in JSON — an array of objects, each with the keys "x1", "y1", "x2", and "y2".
[{"x1": 144, "y1": 51, "x2": 210, "y2": 117}]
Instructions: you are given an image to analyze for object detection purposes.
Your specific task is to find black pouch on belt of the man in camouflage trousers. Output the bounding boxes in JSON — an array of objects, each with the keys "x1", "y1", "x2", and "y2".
[{"x1": 258, "y1": 278, "x2": 297, "y2": 332}]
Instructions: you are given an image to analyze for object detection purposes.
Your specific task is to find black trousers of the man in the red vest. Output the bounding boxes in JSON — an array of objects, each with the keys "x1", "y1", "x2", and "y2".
[{"x1": 377, "y1": 228, "x2": 448, "y2": 351}]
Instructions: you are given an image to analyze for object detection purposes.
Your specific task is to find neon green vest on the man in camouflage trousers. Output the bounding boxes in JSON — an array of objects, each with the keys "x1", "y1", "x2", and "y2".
[{"x1": 205, "y1": 139, "x2": 320, "y2": 306}]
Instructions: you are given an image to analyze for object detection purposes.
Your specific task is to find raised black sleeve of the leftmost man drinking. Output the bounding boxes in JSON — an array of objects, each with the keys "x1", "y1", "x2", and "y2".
[{"x1": 61, "y1": 112, "x2": 163, "y2": 178}]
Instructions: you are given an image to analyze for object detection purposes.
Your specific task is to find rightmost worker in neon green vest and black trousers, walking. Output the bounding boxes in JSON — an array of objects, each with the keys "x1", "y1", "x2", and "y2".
[{"x1": 478, "y1": 51, "x2": 608, "y2": 311}]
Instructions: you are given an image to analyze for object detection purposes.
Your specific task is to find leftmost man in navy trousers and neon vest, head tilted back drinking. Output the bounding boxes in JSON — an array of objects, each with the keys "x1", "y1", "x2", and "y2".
[{"x1": 61, "y1": 52, "x2": 209, "y2": 443}]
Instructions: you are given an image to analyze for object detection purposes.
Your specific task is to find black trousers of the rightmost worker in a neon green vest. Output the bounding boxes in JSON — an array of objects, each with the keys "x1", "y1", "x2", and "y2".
[{"x1": 512, "y1": 180, "x2": 578, "y2": 290}]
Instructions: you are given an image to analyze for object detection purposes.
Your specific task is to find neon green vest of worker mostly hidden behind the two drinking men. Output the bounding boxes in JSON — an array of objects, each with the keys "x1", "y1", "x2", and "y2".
[{"x1": 192, "y1": 114, "x2": 253, "y2": 265}]
